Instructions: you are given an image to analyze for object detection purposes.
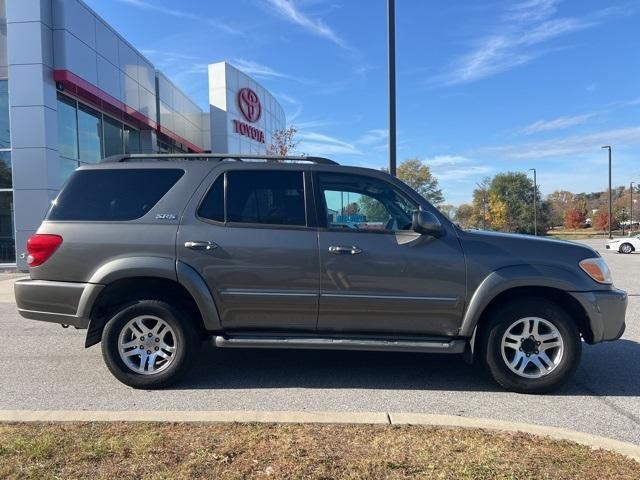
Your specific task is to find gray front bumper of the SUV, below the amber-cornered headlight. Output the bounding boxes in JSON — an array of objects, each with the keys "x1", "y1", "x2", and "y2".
[{"x1": 569, "y1": 288, "x2": 628, "y2": 343}]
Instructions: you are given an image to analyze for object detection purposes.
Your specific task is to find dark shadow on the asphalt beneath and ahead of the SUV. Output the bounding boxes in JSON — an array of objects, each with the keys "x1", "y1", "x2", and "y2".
[{"x1": 173, "y1": 340, "x2": 640, "y2": 396}]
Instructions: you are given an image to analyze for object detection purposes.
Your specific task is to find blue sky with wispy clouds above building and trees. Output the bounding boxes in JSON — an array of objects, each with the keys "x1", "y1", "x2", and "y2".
[{"x1": 85, "y1": 0, "x2": 640, "y2": 205}]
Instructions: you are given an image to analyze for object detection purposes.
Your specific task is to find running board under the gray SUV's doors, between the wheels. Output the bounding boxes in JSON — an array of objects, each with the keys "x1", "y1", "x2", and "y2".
[{"x1": 214, "y1": 336, "x2": 467, "y2": 353}]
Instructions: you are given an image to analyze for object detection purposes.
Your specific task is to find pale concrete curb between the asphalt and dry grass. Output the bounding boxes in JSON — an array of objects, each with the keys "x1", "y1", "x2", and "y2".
[{"x1": 0, "y1": 410, "x2": 640, "y2": 462}]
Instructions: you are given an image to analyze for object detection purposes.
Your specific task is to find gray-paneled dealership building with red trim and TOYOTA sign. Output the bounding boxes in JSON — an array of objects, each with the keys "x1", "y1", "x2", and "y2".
[{"x1": 0, "y1": 0, "x2": 286, "y2": 269}]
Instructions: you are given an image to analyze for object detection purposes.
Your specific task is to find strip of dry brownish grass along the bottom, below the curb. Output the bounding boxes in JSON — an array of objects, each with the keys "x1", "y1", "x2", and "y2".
[{"x1": 0, "y1": 423, "x2": 640, "y2": 480}]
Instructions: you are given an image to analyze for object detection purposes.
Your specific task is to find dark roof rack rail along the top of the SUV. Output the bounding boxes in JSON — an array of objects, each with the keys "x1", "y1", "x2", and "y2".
[{"x1": 101, "y1": 153, "x2": 338, "y2": 165}]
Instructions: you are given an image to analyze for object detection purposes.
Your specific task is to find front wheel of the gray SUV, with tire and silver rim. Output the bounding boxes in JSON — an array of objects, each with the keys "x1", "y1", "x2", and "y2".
[{"x1": 481, "y1": 298, "x2": 582, "y2": 393}]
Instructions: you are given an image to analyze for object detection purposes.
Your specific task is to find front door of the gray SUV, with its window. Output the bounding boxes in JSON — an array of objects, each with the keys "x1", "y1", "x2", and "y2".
[{"x1": 316, "y1": 173, "x2": 466, "y2": 335}]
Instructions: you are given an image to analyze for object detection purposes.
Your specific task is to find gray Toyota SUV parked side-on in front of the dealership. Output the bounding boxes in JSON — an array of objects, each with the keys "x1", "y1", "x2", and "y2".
[{"x1": 15, "y1": 154, "x2": 627, "y2": 393}]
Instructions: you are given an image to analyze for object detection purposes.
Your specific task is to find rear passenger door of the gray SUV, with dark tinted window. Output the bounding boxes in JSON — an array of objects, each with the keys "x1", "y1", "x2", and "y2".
[{"x1": 177, "y1": 164, "x2": 319, "y2": 331}]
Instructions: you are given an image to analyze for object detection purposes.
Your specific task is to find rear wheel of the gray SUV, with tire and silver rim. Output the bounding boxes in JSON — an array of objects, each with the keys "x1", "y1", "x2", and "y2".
[{"x1": 102, "y1": 300, "x2": 201, "y2": 389}]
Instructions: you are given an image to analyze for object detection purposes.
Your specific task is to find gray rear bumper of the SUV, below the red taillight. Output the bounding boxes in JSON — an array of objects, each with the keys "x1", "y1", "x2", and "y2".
[{"x1": 15, "y1": 280, "x2": 104, "y2": 328}]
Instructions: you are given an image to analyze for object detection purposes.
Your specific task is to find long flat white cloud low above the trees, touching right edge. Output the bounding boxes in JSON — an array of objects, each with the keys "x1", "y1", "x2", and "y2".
[{"x1": 476, "y1": 126, "x2": 640, "y2": 160}]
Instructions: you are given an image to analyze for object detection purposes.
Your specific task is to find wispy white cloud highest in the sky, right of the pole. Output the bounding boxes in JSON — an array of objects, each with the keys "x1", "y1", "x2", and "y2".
[{"x1": 433, "y1": 0, "x2": 613, "y2": 86}]
